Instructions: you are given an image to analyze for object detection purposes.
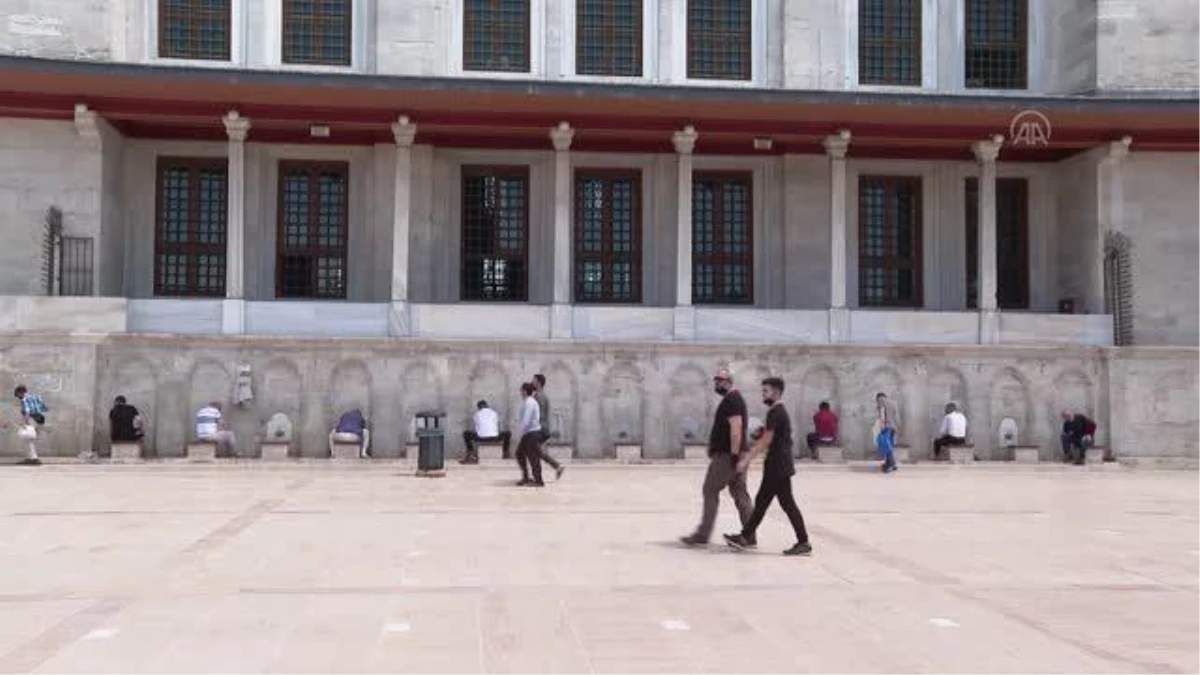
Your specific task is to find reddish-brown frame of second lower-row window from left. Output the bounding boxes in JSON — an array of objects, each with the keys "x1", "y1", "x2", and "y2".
[{"x1": 275, "y1": 160, "x2": 352, "y2": 301}]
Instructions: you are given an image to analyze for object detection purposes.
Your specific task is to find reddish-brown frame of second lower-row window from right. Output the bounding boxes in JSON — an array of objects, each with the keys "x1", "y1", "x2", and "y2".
[{"x1": 856, "y1": 173, "x2": 925, "y2": 309}]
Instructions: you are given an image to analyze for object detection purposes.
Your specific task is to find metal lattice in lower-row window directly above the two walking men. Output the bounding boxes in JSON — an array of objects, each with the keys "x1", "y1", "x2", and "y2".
[{"x1": 691, "y1": 174, "x2": 754, "y2": 304}]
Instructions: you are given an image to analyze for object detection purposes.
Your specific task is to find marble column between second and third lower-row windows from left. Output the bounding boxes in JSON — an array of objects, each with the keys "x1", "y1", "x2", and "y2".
[{"x1": 388, "y1": 117, "x2": 416, "y2": 338}]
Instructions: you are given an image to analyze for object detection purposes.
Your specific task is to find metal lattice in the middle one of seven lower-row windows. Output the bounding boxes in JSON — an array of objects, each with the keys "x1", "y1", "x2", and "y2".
[{"x1": 575, "y1": 172, "x2": 642, "y2": 303}]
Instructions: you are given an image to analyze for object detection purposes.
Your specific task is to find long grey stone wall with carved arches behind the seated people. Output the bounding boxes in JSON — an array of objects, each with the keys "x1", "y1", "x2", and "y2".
[{"x1": 0, "y1": 335, "x2": 1137, "y2": 459}]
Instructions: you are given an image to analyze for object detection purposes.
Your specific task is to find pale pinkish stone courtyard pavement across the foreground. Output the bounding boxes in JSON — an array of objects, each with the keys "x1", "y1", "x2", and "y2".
[{"x1": 0, "y1": 464, "x2": 1200, "y2": 675}]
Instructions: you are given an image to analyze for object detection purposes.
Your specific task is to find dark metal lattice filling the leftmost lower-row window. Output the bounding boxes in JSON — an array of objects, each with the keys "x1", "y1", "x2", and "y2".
[{"x1": 155, "y1": 159, "x2": 228, "y2": 297}]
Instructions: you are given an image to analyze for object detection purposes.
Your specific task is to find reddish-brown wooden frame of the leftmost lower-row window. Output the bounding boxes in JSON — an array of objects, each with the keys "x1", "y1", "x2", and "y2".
[{"x1": 152, "y1": 155, "x2": 229, "y2": 298}]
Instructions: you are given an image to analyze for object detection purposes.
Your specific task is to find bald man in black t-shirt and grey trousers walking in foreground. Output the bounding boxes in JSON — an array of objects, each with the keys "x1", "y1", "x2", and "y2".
[{"x1": 679, "y1": 368, "x2": 752, "y2": 546}]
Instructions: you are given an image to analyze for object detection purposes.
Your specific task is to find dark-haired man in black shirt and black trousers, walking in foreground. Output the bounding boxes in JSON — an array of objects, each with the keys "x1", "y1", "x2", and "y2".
[{"x1": 725, "y1": 377, "x2": 812, "y2": 555}]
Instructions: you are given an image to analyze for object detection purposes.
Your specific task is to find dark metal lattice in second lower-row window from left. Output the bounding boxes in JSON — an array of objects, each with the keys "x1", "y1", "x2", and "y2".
[{"x1": 276, "y1": 162, "x2": 349, "y2": 299}]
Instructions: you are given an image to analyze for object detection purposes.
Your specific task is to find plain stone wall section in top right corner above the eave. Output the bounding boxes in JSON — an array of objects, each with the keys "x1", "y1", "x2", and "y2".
[{"x1": 1097, "y1": 0, "x2": 1200, "y2": 90}]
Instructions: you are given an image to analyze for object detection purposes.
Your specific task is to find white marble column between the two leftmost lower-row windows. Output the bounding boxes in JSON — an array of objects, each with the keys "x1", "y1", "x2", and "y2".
[{"x1": 221, "y1": 110, "x2": 250, "y2": 335}]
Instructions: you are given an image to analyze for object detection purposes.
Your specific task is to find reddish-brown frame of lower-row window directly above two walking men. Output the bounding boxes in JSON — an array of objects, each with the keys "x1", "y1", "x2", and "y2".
[{"x1": 691, "y1": 169, "x2": 756, "y2": 306}]
